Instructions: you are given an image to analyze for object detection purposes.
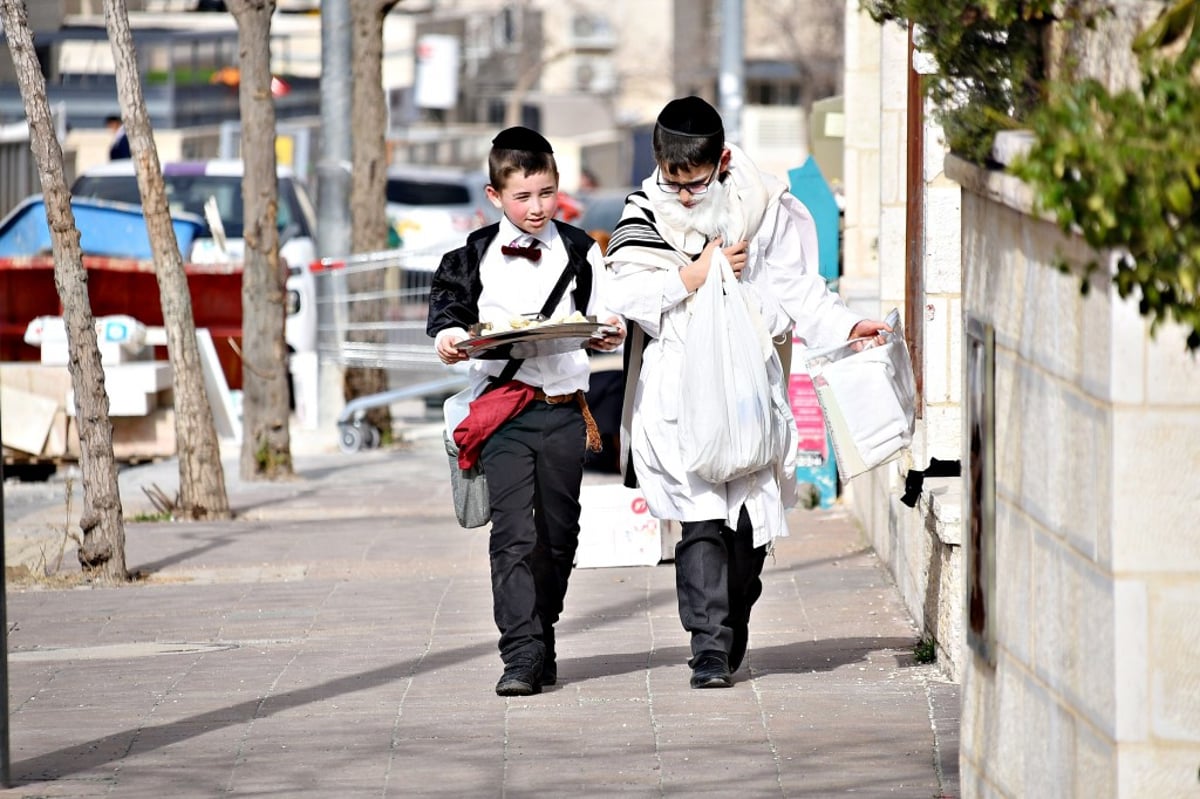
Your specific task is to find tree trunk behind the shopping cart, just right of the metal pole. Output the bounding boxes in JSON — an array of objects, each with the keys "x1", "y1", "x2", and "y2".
[{"x1": 343, "y1": 0, "x2": 400, "y2": 429}]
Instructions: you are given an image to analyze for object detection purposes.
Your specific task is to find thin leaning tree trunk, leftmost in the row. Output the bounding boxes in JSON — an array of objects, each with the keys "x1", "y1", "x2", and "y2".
[{"x1": 0, "y1": 0, "x2": 130, "y2": 583}]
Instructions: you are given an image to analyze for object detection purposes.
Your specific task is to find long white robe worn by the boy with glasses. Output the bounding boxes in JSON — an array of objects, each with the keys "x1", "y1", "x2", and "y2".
[{"x1": 608, "y1": 150, "x2": 863, "y2": 546}]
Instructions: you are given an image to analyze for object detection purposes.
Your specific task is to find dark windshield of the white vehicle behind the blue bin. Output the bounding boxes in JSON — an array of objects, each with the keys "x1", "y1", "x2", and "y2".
[{"x1": 72, "y1": 175, "x2": 306, "y2": 239}]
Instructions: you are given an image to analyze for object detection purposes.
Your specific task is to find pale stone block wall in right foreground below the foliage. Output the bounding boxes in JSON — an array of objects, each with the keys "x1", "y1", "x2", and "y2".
[{"x1": 948, "y1": 160, "x2": 1200, "y2": 798}]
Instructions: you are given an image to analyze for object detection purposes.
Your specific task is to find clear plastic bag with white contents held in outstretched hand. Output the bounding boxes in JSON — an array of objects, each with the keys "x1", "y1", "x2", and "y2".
[{"x1": 805, "y1": 310, "x2": 917, "y2": 480}]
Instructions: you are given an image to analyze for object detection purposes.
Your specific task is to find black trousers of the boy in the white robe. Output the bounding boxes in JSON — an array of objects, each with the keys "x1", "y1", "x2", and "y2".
[{"x1": 676, "y1": 507, "x2": 767, "y2": 669}]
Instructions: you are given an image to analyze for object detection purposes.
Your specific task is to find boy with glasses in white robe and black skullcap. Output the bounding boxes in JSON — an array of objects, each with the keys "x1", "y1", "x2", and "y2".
[{"x1": 606, "y1": 97, "x2": 888, "y2": 689}]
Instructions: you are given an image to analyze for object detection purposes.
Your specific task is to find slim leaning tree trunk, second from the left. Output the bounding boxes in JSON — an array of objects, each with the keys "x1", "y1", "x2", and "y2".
[{"x1": 104, "y1": 0, "x2": 229, "y2": 519}]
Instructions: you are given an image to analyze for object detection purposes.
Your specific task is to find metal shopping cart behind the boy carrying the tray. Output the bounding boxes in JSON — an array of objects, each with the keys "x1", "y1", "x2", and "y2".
[{"x1": 312, "y1": 250, "x2": 467, "y2": 452}]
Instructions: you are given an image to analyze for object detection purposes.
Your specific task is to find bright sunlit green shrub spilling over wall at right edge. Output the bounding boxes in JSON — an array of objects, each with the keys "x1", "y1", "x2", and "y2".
[{"x1": 1013, "y1": 0, "x2": 1200, "y2": 350}]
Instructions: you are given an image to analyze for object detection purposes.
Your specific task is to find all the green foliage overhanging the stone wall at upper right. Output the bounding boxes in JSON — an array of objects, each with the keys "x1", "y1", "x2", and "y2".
[{"x1": 862, "y1": 0, "x2": 1200, "y2": 350}]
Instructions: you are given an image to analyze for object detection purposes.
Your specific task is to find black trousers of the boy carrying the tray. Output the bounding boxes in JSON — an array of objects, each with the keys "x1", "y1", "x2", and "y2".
[{"x1": 480, "y1": 401, "x2": 587, "y2": 663}]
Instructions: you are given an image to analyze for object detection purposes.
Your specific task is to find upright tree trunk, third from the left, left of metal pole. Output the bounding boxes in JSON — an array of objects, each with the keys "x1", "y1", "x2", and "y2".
[{"x1": 228, "y1": 0, "x2": 296, "y2": 480}]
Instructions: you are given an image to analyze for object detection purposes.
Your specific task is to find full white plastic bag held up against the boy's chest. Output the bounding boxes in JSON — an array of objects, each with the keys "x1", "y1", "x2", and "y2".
[{"x1": 679, "y1": 250, "x2": 788, "y2": 483}]
